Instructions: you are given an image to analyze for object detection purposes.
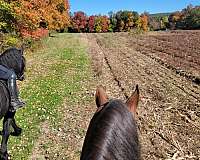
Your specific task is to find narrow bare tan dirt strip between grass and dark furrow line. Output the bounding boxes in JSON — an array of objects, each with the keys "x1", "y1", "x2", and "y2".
[{"x1": 81, "y1": 34, "x2": 124, "y2": 99}]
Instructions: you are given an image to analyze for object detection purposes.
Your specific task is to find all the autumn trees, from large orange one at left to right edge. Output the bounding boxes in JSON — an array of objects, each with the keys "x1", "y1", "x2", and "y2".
[{"x1": 0, "y1": 0, "x2": 200, "y2": 38}]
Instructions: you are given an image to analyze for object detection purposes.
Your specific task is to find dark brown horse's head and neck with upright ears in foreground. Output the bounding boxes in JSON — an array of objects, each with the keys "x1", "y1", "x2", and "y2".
[{"x1": 80, "y1": 85, "x2": 141, "y2": 160}]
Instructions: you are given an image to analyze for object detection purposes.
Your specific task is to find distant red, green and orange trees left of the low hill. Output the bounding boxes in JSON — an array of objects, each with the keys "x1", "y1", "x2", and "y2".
[{"x1": 69, "y1": 11, "x2": 148, "y2": 33}]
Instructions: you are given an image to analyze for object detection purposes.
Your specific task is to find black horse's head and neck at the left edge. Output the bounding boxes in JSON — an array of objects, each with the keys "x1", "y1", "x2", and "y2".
[{"x1": 0, "y1": 48, "x2": 26, "y2": 81}]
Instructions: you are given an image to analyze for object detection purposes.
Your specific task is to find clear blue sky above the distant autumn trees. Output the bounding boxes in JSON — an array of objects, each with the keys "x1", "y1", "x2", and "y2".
[{"x1": 69, "y1": 0, "x2": 200, "y2": 15}]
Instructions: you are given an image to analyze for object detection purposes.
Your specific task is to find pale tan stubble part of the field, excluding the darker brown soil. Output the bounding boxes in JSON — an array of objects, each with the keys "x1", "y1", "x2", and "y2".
[{"x1": 82, "y1": 34, "x2": 200, "y2": 159}]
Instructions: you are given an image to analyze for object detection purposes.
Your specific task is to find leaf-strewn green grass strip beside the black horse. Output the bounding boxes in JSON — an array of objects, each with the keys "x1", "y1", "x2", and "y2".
[{"x1": 0, "y1": 34, "x2": 90, "y2": 160}]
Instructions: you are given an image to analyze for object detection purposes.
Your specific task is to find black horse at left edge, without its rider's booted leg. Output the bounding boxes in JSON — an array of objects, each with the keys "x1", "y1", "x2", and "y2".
[{"x1": 0, "y1": 47, "x2": 26, "y2": 160}]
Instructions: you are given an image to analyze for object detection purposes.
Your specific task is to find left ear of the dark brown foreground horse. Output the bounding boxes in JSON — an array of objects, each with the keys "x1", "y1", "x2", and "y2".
[{"x1": 95, "y1": 85, "x2": 108, "y2": 107}]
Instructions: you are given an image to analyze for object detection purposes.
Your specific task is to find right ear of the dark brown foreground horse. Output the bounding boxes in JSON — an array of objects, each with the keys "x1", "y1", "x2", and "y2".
[{"x1": 126, "y1": 85, "x2": 139, "y2": 114}]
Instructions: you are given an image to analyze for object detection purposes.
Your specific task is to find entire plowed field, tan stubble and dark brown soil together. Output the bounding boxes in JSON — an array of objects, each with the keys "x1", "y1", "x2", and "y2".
[{"x1": 81, "y1": 31, "x2": 200, "y2": 160}]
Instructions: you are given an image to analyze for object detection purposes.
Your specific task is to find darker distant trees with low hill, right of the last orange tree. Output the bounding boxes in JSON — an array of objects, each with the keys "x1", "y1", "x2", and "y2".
[{"x1": 144, "y1": 5, "x2": 200, "y2": 30}]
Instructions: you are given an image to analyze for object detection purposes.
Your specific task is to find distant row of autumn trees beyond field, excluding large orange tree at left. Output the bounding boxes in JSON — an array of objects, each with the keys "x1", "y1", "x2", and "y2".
[{"x1": 69, "y1": 5, "x2": 200, "y2": 33}]
